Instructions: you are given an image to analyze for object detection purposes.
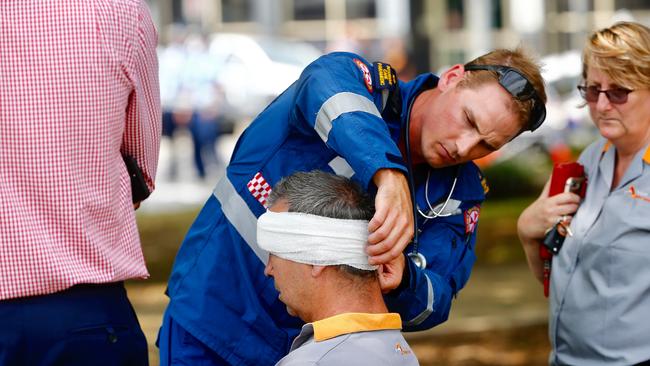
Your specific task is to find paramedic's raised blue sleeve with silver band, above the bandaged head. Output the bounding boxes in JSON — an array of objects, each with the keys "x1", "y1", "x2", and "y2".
[{"x1": 290, "y1": 53, "x2": 406, "y2": 187}]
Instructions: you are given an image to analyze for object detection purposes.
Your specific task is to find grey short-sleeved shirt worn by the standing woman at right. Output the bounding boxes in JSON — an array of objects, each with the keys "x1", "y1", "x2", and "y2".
[{"x1": 549, "y1": 139, "x2": 650, "y2": 366}]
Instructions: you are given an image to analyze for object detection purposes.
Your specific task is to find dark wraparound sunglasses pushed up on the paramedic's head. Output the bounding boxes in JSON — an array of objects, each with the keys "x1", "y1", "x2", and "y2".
[{"x1": 465, "y1": 65, "x2": 546, "y2": 131}]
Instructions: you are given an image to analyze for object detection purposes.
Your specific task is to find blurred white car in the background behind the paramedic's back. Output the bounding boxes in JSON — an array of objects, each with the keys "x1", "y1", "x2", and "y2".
[{"x1": 208, "y1": 33, "x2": 322, "y2": 126}]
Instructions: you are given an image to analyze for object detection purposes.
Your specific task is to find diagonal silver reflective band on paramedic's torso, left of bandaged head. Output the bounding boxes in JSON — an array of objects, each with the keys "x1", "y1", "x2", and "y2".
[{"x1": 212, "y1": 174, "x2": 269, "y2": 265}]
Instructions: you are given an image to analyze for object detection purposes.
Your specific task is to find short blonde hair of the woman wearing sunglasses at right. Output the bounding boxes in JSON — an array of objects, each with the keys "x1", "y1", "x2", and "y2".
[{"x1": 582, "y1": 22, "x2": 650, "y2": 89}]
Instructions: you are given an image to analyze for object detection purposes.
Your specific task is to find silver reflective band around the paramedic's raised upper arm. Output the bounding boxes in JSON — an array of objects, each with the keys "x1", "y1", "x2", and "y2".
[{"x1": 314, "y1": 92, "x2": 381, "y2": 142}]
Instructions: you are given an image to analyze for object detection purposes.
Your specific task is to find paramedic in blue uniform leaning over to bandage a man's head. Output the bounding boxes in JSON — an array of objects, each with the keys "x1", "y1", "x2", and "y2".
[{"x1": 158, "y1": 50, "x2": 546, "y2": 365}]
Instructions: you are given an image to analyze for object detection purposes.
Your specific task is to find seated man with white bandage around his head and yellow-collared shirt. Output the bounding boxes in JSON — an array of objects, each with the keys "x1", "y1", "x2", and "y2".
[{"x1": 257, "y1": 171, "x2": 418, "y2": 366}]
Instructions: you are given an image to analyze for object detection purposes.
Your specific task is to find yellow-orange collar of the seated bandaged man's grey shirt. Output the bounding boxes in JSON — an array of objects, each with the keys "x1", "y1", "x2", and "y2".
[{"x1": 311, "y1": 313, "x2": 402, "y2": 342}]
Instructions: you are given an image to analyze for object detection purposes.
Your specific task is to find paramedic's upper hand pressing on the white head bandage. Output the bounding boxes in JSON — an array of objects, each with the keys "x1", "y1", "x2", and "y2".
[{"x1": 368, "y1": 169, "x2": 413, "y2": 264}]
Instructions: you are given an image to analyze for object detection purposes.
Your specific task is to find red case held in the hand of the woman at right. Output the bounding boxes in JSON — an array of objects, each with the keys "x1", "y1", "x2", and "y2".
[{"x1": 539, "y1": 162, "x2": 587, "y2": 297}]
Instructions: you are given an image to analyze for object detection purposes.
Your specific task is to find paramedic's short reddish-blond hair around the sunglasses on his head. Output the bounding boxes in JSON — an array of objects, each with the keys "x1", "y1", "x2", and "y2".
[{"x1": 459, "y1": 47, "x2": 546, "y2": 132}]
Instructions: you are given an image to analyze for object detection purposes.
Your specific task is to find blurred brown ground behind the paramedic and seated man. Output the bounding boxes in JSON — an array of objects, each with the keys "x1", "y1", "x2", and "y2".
[{"x1": 128, "y1": 265, "x2": 548, "y2": 365}]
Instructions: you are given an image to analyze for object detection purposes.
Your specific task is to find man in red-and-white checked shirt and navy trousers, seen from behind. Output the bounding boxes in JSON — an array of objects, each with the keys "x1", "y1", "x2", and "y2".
[{"x1": 0, "y1": 0, "x2": 161, "y2": 365}]
